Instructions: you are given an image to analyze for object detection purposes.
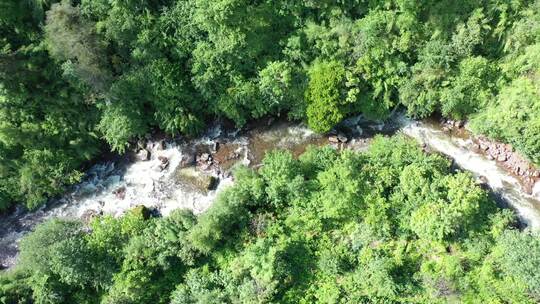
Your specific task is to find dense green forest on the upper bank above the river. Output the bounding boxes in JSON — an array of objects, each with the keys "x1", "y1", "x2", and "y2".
[{"x1": 0, "y1": 0, "x2": 540, "y2": 210}]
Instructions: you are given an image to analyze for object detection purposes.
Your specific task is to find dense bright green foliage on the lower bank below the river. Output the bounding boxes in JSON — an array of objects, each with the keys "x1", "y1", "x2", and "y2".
[{"x1": 0, "y1": 137, "x2": 540, "y2": 304}]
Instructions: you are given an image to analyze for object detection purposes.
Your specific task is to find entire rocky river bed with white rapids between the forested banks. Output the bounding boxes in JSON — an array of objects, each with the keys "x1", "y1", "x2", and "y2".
[{"x1": 0, "y1": 115, "x2": 540, "y2": 268}]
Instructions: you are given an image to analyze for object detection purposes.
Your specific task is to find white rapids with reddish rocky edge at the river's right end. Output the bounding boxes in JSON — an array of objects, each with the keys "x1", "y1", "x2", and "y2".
[{"x1": 401, "y1": 117, "x2": 540, "y2": 230}]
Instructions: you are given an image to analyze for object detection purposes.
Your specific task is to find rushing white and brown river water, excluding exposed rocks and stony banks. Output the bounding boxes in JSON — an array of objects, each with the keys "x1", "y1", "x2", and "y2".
[{"x1": 0, "y1": 115, "x2": 540, "y2": 267}]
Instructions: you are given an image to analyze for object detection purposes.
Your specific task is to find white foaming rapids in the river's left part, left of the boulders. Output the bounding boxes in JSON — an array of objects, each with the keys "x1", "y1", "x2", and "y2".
[{"x1": 0, "y1": 134, "x2": 232, "y2": 267}]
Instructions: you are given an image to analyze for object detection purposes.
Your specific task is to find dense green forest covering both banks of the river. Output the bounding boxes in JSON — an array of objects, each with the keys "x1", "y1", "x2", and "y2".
[{"x1": 0, "y1": 0, "x2": 540, "y2": 304}]
